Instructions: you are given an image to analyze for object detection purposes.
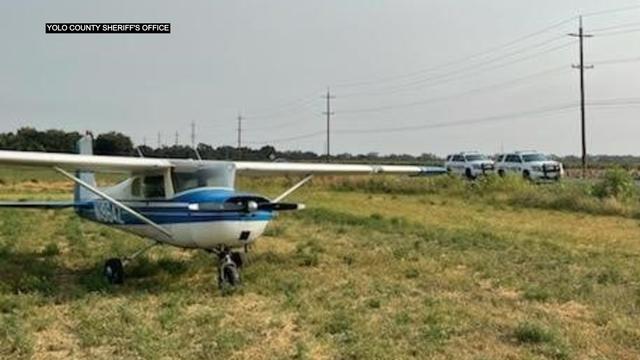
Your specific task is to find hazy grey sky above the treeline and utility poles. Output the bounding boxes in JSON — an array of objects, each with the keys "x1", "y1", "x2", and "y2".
[{"x1": 0, "y1": 0, "x2": 640, "y2": 155}]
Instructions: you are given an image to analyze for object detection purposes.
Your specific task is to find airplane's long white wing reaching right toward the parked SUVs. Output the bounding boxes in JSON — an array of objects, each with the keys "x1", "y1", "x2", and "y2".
[{"x1": 234, "y1": 161, "x2": 447, "y2": 175}]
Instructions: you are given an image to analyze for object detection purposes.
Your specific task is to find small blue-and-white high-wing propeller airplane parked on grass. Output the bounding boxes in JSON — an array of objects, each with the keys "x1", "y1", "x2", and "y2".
[{"x1": 0, "y1": 135, "x2": 446, "y2": 288}]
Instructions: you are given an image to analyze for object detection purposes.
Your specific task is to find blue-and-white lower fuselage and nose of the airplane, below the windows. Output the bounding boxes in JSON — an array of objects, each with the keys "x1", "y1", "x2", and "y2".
[{"x1": 75, "y1": 188, "x2": 275, "y2": 249}]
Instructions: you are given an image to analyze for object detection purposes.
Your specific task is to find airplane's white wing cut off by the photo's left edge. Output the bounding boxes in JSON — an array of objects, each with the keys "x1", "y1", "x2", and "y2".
[{"x1": 0, "y1": 151, "x2": 172, "y2": 172}]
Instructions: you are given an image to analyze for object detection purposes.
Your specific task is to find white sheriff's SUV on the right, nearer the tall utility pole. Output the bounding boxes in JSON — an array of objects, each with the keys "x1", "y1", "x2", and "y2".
[{"x1": 496, "y1": 151, "x2": 564, "y2": 180}]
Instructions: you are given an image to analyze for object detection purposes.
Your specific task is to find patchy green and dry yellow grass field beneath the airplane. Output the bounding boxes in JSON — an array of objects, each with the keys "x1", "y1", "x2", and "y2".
[{"x1": 0, "y1": 171, "x2": 640, "y2": 359}]
